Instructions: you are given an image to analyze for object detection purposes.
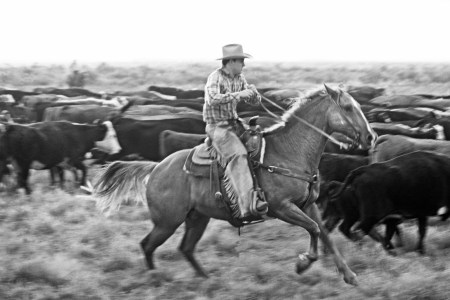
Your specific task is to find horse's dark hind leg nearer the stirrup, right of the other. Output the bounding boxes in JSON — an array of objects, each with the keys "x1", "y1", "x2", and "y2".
[{"x1": 179, "y1": 211, "x2": 210, "y2": 277}]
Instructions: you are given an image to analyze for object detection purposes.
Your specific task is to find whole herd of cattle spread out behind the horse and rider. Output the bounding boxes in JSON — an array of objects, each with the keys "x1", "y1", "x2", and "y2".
[{"x1": 0, "y1": 86, "x2": 450, "y2": 252}]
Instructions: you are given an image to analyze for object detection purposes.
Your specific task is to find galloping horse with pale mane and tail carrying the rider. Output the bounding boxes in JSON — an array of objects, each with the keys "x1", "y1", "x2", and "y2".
[{"x1": 95, "y1": 85, "x2": 376, "y2": 284}]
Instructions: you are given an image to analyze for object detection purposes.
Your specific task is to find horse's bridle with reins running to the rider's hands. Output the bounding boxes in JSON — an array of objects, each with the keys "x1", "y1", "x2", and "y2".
[{"x1": 260, "y1": 91, "x2": 360, "y2": 150}]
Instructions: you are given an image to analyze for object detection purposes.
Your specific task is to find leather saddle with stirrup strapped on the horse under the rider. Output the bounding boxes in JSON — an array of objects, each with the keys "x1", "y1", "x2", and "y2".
[{"x1": 183, "y1": 117, "x2": 264, "y2": 227}]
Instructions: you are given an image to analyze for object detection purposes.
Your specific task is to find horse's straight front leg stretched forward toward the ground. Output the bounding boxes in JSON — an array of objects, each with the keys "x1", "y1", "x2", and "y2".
[{"x1": 306, "y1": 203, "x2": 358, "y2": 285}]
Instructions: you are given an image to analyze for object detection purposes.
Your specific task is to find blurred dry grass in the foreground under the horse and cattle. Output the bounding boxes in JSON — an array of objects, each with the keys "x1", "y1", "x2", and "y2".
[{"x1": 0, "y1": 174, "x2": 450, "y2": 299}]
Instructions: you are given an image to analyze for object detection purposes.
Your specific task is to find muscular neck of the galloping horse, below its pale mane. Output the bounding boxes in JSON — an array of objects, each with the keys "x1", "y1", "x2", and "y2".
[{"x1": 264, "y1": 100, "x2": 329, "y2": 173}]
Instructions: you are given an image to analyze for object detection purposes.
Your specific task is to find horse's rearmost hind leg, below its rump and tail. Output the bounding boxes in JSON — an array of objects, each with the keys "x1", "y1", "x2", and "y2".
[{"x1": 141, "y1": 224, "x2": 180, "y2": 270}]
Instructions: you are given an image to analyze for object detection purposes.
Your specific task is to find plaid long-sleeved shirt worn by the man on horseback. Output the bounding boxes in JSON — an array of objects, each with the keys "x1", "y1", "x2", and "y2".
[{"x1": 203, "y1": 69, "x2": 261, "y2": 124}]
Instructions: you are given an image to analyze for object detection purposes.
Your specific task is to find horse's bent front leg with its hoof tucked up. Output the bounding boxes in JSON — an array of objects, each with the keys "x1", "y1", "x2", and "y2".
[{"x1": 273, "y1": 201, "x2": 320, "y2": 274}]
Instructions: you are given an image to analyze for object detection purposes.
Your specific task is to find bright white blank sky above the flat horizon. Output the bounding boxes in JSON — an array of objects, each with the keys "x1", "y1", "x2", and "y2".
[{"x1": 0, "y1": 0, "x2": 450, "y2": 64}]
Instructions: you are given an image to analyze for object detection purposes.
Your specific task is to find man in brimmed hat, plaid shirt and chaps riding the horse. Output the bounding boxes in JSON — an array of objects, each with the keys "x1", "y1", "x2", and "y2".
[{"x1": 203, "y1": 44, "x2": 267, "y2": 220}]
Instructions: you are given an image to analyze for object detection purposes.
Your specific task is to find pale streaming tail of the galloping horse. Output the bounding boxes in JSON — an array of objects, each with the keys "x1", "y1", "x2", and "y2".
[{"x1": 94, "y1": 161, "x2": 158, "y2": 215}]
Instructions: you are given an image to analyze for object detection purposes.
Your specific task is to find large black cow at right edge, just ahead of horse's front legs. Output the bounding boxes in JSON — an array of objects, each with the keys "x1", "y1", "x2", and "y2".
[{"x1": 330, "y1": 151, "x2": 450, "y2": 253}]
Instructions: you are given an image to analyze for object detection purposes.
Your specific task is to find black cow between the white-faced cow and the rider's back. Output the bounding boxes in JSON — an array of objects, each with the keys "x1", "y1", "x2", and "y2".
[{"x1": 103, "y1": 118, "x2": 206, "y2": 161}]
